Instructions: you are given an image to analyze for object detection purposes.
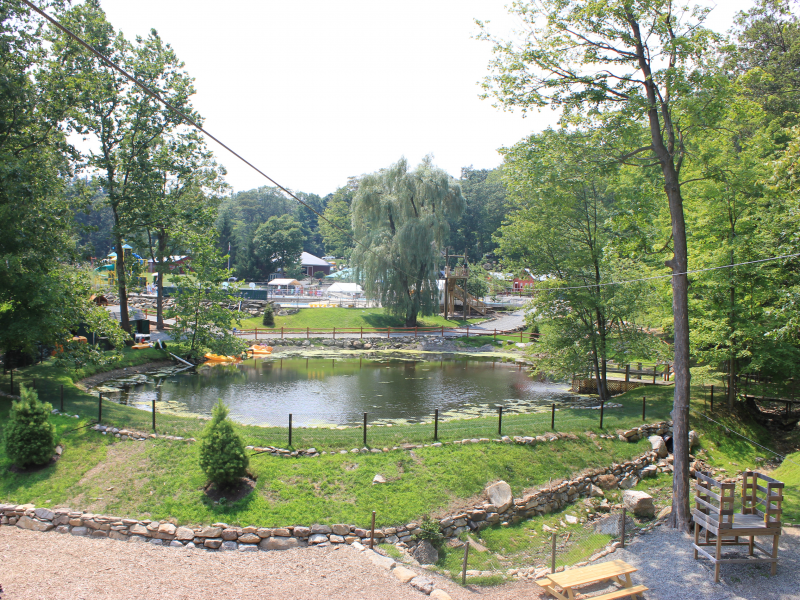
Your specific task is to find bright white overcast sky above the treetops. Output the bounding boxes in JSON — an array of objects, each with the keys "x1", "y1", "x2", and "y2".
[{"x1": 95, "y1": 0, "x2": 752, "y2": 195}]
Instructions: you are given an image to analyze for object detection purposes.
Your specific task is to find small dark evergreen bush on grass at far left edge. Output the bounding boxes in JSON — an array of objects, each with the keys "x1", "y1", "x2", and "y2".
[{"x1": 5, "y1": 385, "x2": 56, "y2": 467}]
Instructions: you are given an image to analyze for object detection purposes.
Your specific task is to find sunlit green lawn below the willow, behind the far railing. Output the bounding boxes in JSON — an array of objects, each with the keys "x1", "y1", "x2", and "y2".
[{"x1": 236, "y1": 307, "x2": 480, "y2": 331}]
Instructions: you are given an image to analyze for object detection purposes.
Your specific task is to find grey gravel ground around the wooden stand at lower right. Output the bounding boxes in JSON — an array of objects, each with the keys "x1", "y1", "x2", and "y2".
[{"x1": 608, "y1": 526, "x2": 800, "y2": 600}]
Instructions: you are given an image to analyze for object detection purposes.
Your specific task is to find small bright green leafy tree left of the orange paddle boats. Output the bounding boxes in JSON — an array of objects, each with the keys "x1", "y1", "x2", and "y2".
[{"x1": 166, "y1": 233, "x2": 245, "y2": 359}]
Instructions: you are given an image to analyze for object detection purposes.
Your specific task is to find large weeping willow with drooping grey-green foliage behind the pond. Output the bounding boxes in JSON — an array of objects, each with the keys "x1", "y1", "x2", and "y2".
[{"x1": 352, "y1": 156, "x2": 464, "y2": 327}]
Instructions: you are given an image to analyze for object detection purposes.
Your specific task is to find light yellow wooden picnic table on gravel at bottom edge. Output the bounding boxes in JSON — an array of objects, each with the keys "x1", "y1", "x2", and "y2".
[{"x1": 536, "y1": 560, "x2": 647, "y2": 600}]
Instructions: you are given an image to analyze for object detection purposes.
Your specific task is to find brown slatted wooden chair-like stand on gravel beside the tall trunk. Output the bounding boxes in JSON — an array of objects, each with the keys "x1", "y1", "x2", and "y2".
[{"x1": 692, "y1": 471, "x2": 783, "y2": 583}]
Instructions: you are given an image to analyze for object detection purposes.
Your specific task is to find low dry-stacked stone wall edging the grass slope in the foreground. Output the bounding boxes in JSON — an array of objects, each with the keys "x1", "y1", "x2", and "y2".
[{"x1": 0, "y1": 422, "x2": 672, "y2": 552}]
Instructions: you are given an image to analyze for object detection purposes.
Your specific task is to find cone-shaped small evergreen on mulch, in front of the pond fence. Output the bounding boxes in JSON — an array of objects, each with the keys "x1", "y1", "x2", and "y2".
[{"x1": 200, "y1": 399, "x2": 250, "y2": 488}]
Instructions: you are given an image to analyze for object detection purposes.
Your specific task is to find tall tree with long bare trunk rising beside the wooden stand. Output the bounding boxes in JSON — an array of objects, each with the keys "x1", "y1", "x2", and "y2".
[{"x1": 484, "y1": 0, "x2": 718, "y2": 531}]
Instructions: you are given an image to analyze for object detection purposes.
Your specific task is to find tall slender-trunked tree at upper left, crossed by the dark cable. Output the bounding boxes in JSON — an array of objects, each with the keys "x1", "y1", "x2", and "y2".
[{"x1": 50, "y1": 0, "x2": 197, "y2": 331}]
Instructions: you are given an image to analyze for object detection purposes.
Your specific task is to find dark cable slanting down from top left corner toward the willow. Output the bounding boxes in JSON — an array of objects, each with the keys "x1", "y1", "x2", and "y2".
[{"x1": 20, "y1": 0, "x2": 424, "y2": 277}]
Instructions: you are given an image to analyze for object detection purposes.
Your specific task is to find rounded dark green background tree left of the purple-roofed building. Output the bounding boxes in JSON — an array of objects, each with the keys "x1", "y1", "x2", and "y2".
[{"x1": 253, "y1": 215, "x2": 303, "y2": 279}]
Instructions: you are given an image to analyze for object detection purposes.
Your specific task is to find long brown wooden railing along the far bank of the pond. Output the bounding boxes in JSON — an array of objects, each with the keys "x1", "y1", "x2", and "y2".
[{"x1": 234, "y1": 326, "x2": 539, "y2": 342}]
